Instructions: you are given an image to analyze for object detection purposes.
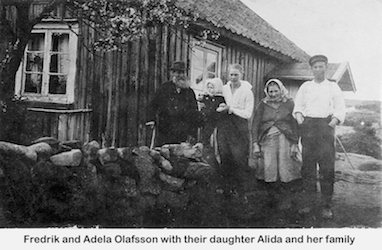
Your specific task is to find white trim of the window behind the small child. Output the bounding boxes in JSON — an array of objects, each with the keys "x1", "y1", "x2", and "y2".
[{"x1": 190, "y1": 38, "x2": 223, "y2": 95}]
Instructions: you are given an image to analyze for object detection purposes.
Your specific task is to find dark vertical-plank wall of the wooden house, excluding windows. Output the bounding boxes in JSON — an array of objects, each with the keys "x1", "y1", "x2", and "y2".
[{"x1": 4, "y1": 2, "x2": 278, "y2": 147}]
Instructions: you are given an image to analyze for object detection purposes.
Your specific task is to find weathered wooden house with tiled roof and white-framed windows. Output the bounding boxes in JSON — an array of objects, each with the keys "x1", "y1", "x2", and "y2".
[{"x1": 9, "y1": 0, "x2": 316, "y2": 147}]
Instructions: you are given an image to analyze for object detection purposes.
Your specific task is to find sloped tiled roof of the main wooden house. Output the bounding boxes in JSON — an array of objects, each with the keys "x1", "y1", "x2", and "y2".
[{"x1": 178, "y1": 0, "x2": 310, "y2": 62}]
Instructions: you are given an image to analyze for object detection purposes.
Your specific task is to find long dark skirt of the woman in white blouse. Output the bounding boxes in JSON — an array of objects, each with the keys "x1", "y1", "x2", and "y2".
[{"x1": 217, "y1": 115, "x2": 249, "y2": 192}]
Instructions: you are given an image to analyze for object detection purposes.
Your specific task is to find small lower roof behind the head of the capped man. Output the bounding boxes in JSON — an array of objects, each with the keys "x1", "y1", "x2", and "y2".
[{"x1": 268, "y1": 62, "x2": 356, "y2": 91}]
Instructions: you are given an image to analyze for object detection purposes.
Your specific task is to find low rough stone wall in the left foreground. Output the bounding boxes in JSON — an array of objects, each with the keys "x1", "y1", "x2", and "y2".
[{"x1": 0, "y1": 137, "x2": 219, "y2": 227}]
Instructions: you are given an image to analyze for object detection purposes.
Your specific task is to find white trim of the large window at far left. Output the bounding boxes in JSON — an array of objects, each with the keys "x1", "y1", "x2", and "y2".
[{"x1": 15, "y1": 23, "x2": 78, "y2": 104}]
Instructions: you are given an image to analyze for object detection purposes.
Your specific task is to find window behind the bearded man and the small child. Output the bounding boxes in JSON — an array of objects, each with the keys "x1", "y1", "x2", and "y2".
[{"x1": 191, "y1": 43, "x2": 222, "y2": 95}]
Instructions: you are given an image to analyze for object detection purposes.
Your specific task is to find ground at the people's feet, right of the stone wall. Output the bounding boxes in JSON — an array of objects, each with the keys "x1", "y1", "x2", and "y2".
[{"x1": 0, "y1": 154, "x2": 382, "y2": 228}]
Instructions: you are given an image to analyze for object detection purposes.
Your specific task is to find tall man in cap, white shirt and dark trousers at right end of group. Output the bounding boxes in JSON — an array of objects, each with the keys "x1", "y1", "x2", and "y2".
[{"x1": 293, "y1": 55, "x2": 345, "y2": 219}]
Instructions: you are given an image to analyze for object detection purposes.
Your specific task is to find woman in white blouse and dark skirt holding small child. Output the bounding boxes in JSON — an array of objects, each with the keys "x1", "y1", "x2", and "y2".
[{"x1": 217, "y1": 64, "x2": 254, "y2": 196}]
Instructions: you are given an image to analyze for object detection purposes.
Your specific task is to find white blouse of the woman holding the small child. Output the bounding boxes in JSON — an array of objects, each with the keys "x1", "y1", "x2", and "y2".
[{"x1": 223, "y1": 80, "x2": 254, "y2": 120}]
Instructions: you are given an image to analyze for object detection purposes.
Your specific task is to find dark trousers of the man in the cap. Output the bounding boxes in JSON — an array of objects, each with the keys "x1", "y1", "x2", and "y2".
[{"x1": 300, "y1": 117, "x2": 335, "y2": 205}]
